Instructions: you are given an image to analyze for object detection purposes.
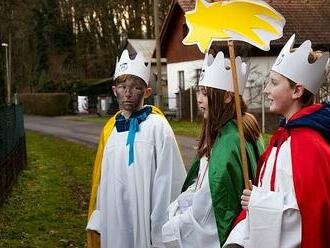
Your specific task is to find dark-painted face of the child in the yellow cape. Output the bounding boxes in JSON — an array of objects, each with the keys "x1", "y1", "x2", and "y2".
[{"x1": 113, "y1": 78, "x2": 147, "y2": 114}]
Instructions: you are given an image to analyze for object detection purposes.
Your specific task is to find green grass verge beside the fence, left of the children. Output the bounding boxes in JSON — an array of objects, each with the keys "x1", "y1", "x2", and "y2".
[{"x1": 0, "y1": 132, "x2": 95, "y2": 248}]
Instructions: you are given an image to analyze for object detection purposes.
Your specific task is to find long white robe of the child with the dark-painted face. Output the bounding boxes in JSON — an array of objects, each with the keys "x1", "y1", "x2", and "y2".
[{"x1": 87, "y1": 114, "x2": 186, "y2": 248}]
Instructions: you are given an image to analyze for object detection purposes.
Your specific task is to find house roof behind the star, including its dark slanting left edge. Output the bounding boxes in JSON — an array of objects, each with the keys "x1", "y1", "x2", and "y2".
[{"x1": 160, "y1": 0, "x2": 330, "y2": 54}]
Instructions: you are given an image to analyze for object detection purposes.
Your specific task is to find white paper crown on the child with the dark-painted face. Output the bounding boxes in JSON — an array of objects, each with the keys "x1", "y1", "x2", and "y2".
[{"x1": 114, "y1": 50, "x2": 150, "y2": 85}]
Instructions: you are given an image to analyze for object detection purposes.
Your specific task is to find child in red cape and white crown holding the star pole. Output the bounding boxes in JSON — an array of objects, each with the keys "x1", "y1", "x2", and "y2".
[{"x1": 224, "y1": 35, "x2": 330, "y2": 248}]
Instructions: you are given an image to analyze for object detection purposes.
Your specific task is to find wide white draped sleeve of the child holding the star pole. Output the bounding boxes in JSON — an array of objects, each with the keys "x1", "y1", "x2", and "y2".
[{"x1": 224, "y1": 188, "x2": 301, "y2": 248}]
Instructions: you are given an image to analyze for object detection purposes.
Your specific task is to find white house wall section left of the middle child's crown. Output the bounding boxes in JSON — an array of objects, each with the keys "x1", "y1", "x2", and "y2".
[{"x1": 167, "y1": 60, "x2": 203, "y2": 109}]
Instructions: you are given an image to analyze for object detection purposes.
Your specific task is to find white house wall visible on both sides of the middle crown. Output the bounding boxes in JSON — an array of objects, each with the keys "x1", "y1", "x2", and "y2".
[{"x1": 167, "y1": 57, "x2": 276, "y2": 109}]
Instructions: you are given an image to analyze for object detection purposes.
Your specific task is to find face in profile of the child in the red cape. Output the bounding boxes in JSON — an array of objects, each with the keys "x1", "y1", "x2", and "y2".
[{"x1": 263, "y1": 71, "x2": 296, "y2": 118}]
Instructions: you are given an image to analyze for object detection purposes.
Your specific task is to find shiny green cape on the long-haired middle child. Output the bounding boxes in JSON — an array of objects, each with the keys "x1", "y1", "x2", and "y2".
[{"x1": 182, "y1": 121, "x2": 264, "y2": 245}]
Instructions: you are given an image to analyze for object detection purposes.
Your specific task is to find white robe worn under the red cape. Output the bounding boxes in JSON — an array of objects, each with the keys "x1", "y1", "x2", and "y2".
[{"x1": 224, "y1": 137, "x2": 301, "y2": 248}]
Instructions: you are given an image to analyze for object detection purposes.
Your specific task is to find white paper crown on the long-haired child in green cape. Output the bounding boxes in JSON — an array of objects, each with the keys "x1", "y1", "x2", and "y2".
[{"x1": 198, "y1": 52, "x2": 247, "y2": 95}]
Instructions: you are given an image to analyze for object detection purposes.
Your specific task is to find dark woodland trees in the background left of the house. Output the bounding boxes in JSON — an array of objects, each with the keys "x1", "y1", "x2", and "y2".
[{"x1": 0, "y1": 0, "x2": 170, "y2": 96}]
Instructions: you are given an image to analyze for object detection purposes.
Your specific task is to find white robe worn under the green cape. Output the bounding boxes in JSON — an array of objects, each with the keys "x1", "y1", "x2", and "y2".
[{"x1": 163, "y1": 157, "x2": 220, "y2": 248}]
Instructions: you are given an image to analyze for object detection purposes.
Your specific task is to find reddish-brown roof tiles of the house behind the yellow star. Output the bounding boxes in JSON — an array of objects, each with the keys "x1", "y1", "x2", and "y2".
[{"x1": 177, "y1": 0, "x2": 330, "y2": 49}]
